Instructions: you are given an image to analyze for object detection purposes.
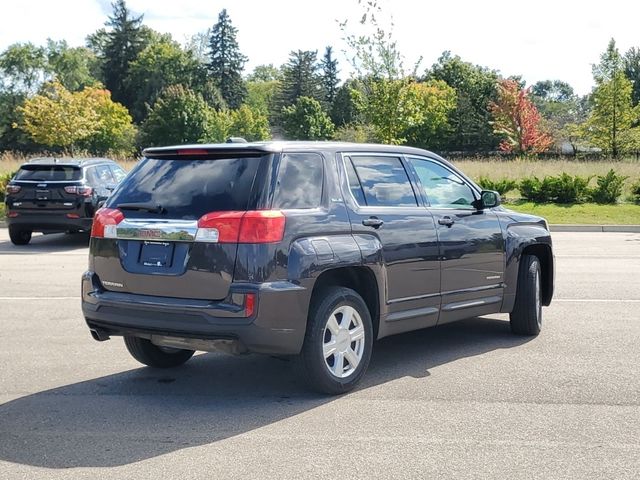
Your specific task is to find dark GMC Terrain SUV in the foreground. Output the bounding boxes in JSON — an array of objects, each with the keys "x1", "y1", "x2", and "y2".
[{"x1": 82, "y1": 142, "x2": 554, "y2": 393}]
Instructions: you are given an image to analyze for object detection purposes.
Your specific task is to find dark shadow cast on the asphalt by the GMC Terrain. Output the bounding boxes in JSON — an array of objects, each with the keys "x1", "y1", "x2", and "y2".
[{"x1": 0, "y1": 317, "x2": 530, "y2": 468}]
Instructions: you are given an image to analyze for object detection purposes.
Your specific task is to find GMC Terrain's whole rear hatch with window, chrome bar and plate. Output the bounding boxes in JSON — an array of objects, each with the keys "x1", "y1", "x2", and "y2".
[{"x1": 91, "y1": 152, "x2": 273, "y2": 300}]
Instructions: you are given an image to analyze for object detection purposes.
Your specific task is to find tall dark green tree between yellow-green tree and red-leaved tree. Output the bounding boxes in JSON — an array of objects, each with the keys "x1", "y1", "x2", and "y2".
[{"x1": 426, "y1": 51, "x2": 498, "y2": 151}]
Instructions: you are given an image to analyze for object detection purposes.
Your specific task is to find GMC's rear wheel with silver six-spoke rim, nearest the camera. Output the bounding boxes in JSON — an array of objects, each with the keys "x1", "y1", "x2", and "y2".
[{"x1": 300, "y1": 287, "x2": 373, "y2": 395}]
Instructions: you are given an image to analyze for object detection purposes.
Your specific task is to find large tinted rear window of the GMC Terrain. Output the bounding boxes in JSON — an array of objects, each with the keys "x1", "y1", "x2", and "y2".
[{"x1": 108, "y1": 157, "x2": 262, "y2": 220}]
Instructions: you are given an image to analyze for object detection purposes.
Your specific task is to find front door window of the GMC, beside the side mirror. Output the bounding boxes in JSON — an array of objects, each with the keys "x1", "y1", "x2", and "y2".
[{"x1": 409, "y1": 158, "x2": 475, "y2": 209}]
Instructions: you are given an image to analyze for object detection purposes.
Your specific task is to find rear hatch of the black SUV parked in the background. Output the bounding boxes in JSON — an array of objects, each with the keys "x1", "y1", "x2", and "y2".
[{"x1": 7, "y1": 164, "x2": 83, "y2": 213}]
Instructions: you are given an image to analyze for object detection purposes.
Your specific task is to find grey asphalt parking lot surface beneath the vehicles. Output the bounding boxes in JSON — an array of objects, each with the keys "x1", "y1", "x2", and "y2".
[{"x1": 0, "y1": 229, "x2": 640, "y2": 479}]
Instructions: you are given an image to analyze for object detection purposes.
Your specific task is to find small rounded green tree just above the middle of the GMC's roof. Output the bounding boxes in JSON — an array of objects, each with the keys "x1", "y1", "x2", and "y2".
[{"x1": 282, "y1": 97, "x2": 334, "y2": 140}]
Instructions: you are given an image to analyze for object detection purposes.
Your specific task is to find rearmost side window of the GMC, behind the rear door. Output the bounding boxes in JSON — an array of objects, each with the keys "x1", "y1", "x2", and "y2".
[{"x1": 273, "y1": 153, "x2": 324, "y2": 208}]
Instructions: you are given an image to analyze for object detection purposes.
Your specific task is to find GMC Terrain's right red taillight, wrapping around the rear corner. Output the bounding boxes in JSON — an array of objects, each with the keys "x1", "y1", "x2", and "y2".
[{"x1": 196, "y1": 210, "x2": 285, "y2": 243}]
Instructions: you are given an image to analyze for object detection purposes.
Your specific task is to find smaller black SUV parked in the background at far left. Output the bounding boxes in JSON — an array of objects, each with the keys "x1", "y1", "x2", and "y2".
[{"x1": 5, "y1": 158, "x2": 126, "y2": 245}]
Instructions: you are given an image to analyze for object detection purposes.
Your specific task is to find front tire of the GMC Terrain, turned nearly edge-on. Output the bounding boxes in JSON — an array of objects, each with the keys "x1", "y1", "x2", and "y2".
[{"x1": 509, "y1": 255, "x2": 542, "y2": 335}]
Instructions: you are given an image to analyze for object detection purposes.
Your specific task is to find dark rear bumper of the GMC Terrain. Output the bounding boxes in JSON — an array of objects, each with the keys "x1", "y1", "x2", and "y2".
[{"x1": 82, "y1": 272, "x2": 309, "y2": 355}]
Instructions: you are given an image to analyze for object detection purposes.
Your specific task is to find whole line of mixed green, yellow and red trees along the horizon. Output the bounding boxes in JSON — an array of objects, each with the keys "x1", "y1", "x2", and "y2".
[{"x1": 0, "y1": 0, "x2": 640, "y2": 157}]
